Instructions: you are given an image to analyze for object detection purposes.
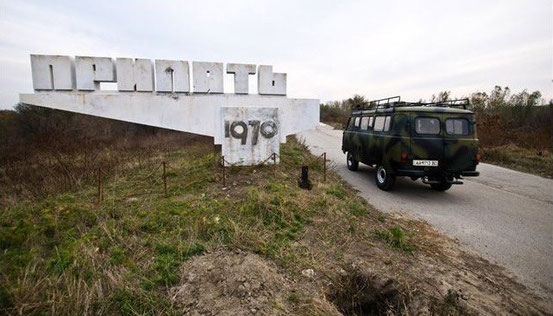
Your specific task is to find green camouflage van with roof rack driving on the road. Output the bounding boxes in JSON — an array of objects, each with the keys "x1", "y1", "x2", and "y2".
[{"x1": 342, "y1": 97, "x2": 480, "y2": 191}]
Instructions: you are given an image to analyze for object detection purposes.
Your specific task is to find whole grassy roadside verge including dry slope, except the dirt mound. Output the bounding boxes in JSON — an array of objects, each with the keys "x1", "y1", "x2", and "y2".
[{"x1": 0, "y1": 139, "x2": 541, "y2": 315}]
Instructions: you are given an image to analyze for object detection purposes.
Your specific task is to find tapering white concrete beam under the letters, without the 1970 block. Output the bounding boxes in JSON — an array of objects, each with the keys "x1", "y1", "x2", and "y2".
[{"x1": 20, "y1": 91, "x2": 319, "y2": 144}]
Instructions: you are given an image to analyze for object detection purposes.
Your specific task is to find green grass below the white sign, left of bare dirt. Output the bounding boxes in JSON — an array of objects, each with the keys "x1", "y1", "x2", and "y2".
[{"x1": 0, "y1": 140, "x2": 368, "y2": 314}]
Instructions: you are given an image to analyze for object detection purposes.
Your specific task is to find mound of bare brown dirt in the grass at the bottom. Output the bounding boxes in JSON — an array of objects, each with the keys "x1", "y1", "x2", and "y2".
[{"x1": 171, "y1": 250, "x2": 292, "y2": 315}]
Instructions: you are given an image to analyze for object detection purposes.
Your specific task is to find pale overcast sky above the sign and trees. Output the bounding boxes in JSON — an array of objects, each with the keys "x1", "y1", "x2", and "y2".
[{"x1": 0, "y1": 0, "x2": 553, "y2": 108}]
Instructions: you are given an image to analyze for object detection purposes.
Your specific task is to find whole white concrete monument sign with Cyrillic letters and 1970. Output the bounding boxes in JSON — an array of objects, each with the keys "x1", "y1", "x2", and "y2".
[{"x1": 20, "y1": 55, "x2": 319, "y2": 165}]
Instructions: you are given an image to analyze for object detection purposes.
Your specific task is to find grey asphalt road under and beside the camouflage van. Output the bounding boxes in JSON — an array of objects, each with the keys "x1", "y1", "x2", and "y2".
[{"x1": 298, "y1": 124, "x2": 553, "y2": 302}]
